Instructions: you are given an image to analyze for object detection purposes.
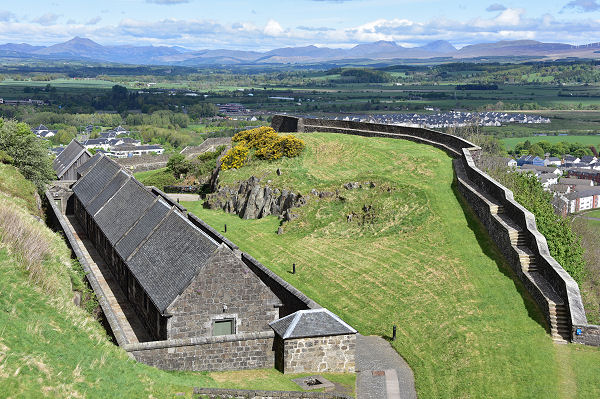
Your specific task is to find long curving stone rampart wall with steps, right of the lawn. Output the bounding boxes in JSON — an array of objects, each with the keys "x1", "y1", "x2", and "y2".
[{"x1": 271, "y1": 115, "x2": 600, "y2": 346}]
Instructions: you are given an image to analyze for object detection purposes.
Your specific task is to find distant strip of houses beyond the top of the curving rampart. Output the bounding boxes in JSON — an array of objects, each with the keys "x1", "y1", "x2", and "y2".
[{"x1": 336, "y1": 111, "x2": 550, "y2": 128}]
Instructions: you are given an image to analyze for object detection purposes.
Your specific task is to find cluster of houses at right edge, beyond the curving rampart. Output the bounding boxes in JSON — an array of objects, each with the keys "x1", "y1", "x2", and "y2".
[{"x1": 507, "y1": 155, "x2": 600, "y2": 215}]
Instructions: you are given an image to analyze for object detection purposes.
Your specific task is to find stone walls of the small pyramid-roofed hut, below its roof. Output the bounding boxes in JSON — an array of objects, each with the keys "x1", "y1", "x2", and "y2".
[{"x1": 275, "y1": 334, "x2": 356, "y2": 374}]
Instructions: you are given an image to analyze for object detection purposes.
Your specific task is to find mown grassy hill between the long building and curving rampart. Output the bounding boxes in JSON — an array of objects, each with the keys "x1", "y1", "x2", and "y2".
[{"x1": 185, "y1": 134, "x2": 600, "y2": 398}]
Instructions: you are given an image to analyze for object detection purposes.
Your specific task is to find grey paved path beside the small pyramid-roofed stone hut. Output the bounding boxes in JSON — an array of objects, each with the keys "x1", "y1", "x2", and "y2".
[{"x1": 356, "y1": 334, "x2": 417, "y2": 399}]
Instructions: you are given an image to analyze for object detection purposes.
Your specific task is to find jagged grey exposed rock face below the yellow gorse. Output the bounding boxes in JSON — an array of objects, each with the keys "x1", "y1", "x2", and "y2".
[{"x1": 204, "y1": 176, "x2": 306, "y2": 221}]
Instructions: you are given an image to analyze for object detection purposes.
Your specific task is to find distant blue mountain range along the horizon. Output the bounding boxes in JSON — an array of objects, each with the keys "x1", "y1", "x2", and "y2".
[{"x1": 0, "y1": 37, "x2": 600, "y2": 66}]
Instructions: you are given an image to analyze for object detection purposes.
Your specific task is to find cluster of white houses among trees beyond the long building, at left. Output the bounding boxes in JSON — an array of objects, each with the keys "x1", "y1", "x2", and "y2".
[{"x1": 49, "y1": 125, "x2": 165, "y2": 158}]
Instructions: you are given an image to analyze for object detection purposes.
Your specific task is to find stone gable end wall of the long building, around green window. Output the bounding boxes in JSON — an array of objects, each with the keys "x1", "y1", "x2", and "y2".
[{"x1": 167, "y1": 245, "x2": 280, "y2": 339}]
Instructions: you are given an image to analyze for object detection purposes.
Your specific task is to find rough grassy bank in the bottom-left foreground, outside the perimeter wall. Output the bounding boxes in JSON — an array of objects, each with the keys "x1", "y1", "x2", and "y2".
[{"x1": 0, "y1": 164, "x2": 354, "y2": 398}]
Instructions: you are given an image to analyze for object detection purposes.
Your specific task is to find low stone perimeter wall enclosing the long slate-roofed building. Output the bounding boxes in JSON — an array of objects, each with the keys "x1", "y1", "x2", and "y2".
[{"x1": 46, "y1": 181, "x2": 321, "y2": 371}]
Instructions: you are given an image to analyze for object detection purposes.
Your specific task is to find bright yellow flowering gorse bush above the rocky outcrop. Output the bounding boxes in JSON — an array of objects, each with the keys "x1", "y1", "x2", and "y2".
[{"x1": 221, "y1": 126, "x2": 305, "y2": 170}]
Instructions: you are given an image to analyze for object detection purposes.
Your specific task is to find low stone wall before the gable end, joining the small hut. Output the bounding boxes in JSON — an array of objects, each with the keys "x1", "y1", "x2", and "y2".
[{"x1": 123, "y1": 331, "x2": 275, "y2": 371}]
